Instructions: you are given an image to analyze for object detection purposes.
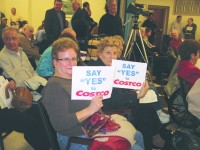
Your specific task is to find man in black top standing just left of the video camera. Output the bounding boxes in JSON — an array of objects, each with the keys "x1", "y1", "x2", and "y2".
[{"x1": 98, "y1": 0, "x2": 123, "y2": 37}]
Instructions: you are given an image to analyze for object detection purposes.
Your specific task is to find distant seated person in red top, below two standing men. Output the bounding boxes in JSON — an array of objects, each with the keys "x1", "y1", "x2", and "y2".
[{"x1": 169, "y1": 29, "x2": 182, "y2": 54}]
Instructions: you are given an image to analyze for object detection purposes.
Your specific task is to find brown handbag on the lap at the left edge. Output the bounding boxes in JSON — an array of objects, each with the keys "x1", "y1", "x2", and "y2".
[{"x1": 6, "y1": 87, "x2": 33, "y2": 112}]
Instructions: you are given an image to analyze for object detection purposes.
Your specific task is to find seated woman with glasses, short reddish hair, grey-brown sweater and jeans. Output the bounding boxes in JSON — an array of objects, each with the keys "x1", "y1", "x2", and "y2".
[{"x1": 42, "y1": 38, "x2": 143, "y2": 150}]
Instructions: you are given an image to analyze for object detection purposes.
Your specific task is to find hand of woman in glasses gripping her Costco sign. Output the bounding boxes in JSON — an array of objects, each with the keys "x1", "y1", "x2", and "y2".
[{"x1": 88, "y1": 95, "x2": 103, "y2": 115}]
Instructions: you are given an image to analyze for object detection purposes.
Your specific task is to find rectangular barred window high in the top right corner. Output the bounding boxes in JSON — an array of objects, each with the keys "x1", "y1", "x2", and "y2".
[{"x1": 174, "y1": 0, "x2": 200, "y2": 16}]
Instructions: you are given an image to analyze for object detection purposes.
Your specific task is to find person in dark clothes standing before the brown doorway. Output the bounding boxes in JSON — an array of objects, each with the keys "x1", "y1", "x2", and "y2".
[{"x1": 142, "y1": 13, "x2": 157, "y2": 44}]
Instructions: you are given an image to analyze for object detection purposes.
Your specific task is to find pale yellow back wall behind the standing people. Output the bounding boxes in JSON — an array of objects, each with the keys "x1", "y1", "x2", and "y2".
[{"x1": 0, "y1": 0, "x2": 200, "y2": 39}]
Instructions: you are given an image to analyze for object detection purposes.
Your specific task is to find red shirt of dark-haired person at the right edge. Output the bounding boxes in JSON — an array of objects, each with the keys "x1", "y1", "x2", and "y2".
[{"x1": 177, "y1": 60, "x2": 200, "y2": 86}]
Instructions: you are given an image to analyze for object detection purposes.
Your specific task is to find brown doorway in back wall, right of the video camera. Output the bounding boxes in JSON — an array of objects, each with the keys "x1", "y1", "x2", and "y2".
[{"x1": 148, "y1": 5, "x2": 170, "y2": 48}]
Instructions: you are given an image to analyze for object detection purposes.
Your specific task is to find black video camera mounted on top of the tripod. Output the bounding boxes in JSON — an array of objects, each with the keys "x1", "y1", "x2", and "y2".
[{"x1": 126, "y1": 2, "x2": 149, "y2": 16}]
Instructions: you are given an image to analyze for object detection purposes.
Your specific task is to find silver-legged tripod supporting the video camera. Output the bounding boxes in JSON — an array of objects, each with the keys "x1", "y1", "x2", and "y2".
[{"x1": 123, "y1": 15, "x2": 152, "y2": 81}]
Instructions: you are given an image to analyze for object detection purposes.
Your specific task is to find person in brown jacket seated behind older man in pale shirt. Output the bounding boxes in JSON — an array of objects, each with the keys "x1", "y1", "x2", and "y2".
[{"x1": 19, "y1": 24, "x2": 40, "y2": 68}]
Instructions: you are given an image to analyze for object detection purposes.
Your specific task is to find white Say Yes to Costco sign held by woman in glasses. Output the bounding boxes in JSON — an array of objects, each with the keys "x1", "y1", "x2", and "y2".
[{"x1": 71, "y1": 66, "x2": 114, "y2": 100}]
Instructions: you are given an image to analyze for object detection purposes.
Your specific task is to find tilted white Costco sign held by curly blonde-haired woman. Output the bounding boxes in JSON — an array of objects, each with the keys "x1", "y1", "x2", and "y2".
[{"x1": 112, "y1": 60, "x2": 147, "y2": 89}]
